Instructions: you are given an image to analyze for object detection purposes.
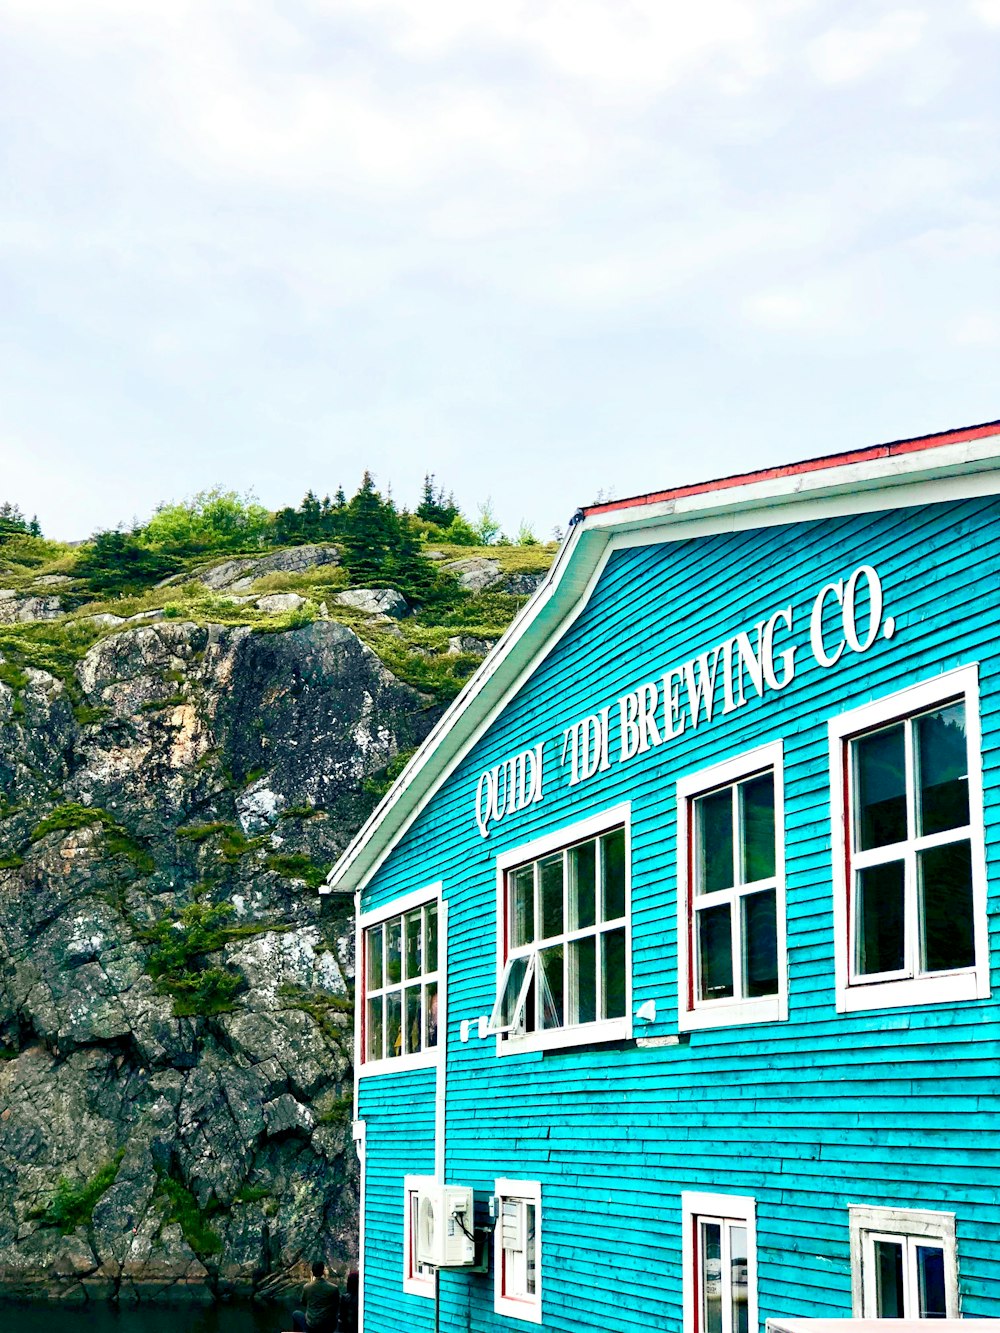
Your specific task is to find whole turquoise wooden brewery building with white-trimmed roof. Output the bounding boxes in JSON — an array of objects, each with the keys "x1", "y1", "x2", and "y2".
[{"x1": 327, "y1": 424, "x2": 1000, "y2": 1333}]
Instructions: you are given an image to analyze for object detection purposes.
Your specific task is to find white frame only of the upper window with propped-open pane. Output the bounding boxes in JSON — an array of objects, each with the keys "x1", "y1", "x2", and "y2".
[{"x1": 493, "y1": 801, "x2": 632, "y2": 1056}]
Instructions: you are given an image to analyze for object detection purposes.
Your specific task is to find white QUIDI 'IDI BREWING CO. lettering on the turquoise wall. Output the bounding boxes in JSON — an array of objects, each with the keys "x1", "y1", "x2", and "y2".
[{"x1": 476, "y1": 565, "x2": 896, "y2": 837}]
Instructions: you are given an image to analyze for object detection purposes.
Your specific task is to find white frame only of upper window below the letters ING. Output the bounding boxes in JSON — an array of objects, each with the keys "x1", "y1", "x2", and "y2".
[{"x1": 677, "y1": 741, "x2": 788, "y2": 1032}]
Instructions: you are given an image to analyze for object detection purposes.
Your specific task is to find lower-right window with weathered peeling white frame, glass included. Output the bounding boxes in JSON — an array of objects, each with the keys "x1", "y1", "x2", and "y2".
[{"x1": 849, "y1": 1204, "x2": 959, "y2": 1320}]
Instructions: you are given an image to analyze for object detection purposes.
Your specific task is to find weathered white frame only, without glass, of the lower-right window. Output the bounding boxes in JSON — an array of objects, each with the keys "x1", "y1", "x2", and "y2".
[{"x1": 848, "y1": 1204, "x2": 961, "y2": 1328}]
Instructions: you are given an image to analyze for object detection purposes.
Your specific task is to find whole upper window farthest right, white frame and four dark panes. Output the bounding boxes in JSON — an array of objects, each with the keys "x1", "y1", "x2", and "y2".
[{"x1": 829, "y1": 667, "x2": 989, "y2": 1012}]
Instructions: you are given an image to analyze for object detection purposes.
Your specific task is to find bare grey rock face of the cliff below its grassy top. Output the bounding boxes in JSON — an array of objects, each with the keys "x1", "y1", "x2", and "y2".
[{"x1": 0, "y1": 599, "x2": 453, "y2": 1300}]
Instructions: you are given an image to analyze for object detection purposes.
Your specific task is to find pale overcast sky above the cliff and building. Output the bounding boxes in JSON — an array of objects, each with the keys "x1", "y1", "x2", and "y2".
[{"x1": 0, "y1": 0, "x2": 1000, "y2": 539}]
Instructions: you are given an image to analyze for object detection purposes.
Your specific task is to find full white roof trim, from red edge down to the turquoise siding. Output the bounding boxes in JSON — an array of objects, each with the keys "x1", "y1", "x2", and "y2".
[{"x1": 320, "y1": 427, "x2": 1000, "y2": 893}]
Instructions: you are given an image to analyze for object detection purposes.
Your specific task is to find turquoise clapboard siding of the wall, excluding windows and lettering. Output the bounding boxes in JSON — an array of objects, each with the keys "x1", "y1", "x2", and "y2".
[{"x1": 359, "y1": 499, "x2": 1000, "y2": 1333}]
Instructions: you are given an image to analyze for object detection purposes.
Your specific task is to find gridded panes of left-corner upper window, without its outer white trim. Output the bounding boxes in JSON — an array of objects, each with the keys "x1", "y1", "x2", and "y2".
[{"x1": 361, "y1": 901, "x2": 440, "y2": 1065}]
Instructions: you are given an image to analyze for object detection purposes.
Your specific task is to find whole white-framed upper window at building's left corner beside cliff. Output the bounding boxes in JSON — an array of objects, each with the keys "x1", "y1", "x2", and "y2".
[{"x1": 357, "y1": 884, "x2": 445, "y2": 1077}]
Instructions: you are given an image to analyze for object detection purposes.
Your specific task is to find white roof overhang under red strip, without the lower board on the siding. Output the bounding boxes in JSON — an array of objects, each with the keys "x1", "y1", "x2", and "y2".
[{"x1": 320, "y1": 425, "x2": 1000, "y2": 893}]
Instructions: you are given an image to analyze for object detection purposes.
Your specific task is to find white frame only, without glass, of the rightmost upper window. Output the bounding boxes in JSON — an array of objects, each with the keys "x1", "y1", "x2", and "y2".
[{"x1": 829, "y1": 665, "x2": 989, "y2": 1013}]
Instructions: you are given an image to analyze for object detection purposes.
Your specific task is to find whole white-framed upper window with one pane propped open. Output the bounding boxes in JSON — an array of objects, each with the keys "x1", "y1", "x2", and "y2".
[{"x1": 489, "y1": 804, "x2": 632, "y2": 1053}]
